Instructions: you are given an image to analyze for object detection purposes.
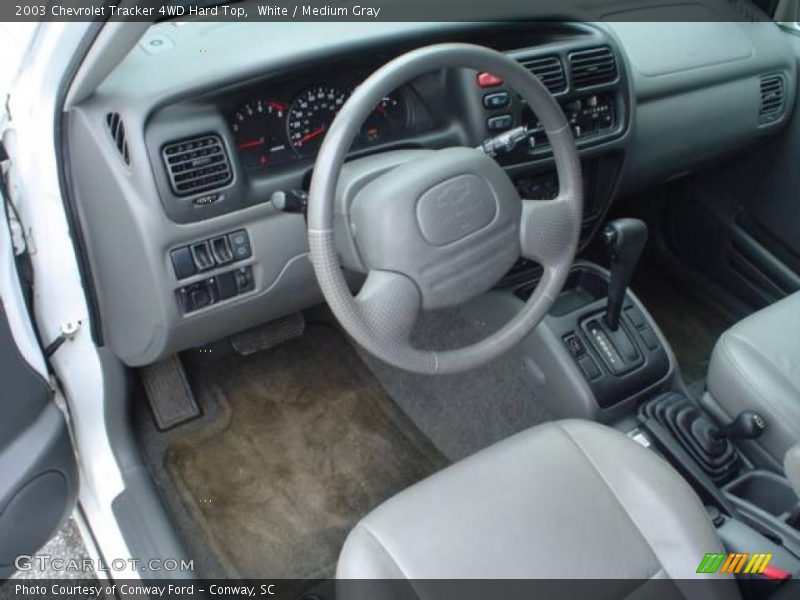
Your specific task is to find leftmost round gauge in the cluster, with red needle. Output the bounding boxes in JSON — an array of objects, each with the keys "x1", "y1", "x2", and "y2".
[{"x1": 231, "y1": 100, "x2": 294, "y2": 170}]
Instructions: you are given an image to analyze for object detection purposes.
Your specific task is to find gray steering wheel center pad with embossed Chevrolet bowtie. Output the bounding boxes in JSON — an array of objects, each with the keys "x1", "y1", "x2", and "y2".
[{"x1": 350, "y1": 148, "x2": 522, "y2": 309}]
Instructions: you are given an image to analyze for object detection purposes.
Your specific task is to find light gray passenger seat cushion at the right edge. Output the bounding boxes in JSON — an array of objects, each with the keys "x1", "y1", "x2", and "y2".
[{"x1": 706, "y1": 293, "x2": 800, "y2": 464}]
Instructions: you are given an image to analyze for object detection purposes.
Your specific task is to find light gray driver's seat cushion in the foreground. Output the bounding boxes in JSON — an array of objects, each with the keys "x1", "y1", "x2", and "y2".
[{"x1": 336, "y1": 420, "x2": 739, "y2": 599}]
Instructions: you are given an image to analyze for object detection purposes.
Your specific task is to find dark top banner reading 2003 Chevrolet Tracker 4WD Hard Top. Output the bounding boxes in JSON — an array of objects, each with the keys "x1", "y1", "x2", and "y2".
[{"x1": 0, "y1": 0, "x2": 784, "y2": 22}]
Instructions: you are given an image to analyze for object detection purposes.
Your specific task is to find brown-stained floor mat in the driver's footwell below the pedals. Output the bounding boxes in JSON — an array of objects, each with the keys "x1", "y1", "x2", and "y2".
[{"x1": 166, "y1": 325, "x2": 447, "y2": 579}]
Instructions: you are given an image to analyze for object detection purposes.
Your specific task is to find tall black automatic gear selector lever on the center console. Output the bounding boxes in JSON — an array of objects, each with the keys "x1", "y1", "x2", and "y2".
[{"x1": 603, "y1": 219, "x2": 647, "y2": 331}]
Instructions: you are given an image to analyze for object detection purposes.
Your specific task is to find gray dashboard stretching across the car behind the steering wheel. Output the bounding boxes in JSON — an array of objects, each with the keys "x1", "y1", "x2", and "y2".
[{"x1": 66, "y1": 14, "x2": 796, "y2": 366}]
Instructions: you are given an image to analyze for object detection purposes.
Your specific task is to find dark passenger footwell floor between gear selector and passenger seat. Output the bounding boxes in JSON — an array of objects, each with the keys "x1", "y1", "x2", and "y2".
[{"x1": 631, "y1": 263, "x2": 733, "y2": 394}]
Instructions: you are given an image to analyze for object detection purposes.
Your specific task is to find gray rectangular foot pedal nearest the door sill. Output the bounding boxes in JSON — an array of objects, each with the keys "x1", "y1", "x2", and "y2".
[{"x1": 142, "y1": 354, "x2": 200, "y2": 431}]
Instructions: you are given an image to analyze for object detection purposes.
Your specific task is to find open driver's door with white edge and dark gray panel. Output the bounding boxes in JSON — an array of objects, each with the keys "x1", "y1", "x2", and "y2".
[{"x1": 0, "y1": 186, "x2": 78, "y2": 578}]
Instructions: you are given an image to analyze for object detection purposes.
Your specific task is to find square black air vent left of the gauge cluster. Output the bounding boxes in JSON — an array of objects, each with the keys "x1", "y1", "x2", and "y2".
[{"x1": 162, "y1": 134, "x2": 233, "y2": 196}]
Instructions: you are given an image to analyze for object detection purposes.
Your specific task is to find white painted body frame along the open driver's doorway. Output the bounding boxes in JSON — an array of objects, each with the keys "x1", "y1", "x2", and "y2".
[{"x1": 0, "y1": 23, "x2": 138, "y2": 578}]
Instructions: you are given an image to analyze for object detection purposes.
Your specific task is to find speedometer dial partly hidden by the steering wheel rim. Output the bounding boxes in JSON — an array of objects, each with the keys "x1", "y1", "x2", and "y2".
[{"x1": 286, "y1": 85, "x2": 347, "y2": 155}]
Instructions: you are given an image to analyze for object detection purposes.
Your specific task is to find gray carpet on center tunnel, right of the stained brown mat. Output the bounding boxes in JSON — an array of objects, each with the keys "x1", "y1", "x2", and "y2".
[{"x1": 359, "y1": 309, "x2": 552, "y2": 461}]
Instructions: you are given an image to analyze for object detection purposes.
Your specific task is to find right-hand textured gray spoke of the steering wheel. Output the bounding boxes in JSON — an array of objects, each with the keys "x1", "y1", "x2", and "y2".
[{"x1": 520, "y1": 195, "x2": 580, "y2": 267}]
